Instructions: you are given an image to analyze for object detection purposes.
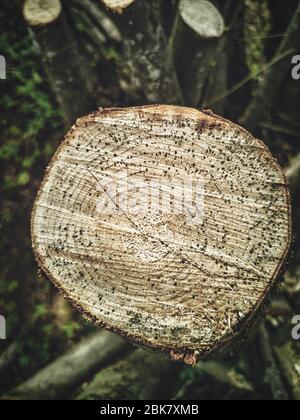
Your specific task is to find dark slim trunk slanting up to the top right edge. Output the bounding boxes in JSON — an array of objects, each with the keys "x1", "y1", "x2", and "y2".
[{"x1": 240, "y1": 4, "x2": 300, "y2": 132}]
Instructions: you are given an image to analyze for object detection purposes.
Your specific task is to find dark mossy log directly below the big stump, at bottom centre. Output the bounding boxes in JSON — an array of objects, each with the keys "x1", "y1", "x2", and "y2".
[{"x1": 77, "y1": 349, "x2": 176, "y2": 400}]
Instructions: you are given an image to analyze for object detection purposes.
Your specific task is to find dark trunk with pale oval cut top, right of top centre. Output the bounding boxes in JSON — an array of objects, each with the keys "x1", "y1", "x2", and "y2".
[{"x1": 170, "y1": 0, "x2": 225, "y2": 106}]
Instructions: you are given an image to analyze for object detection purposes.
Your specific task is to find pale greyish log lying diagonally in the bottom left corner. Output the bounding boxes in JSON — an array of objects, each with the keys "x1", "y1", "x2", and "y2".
[{"x1": 3, "y1": 331, "x2": 129, "y2": 400}]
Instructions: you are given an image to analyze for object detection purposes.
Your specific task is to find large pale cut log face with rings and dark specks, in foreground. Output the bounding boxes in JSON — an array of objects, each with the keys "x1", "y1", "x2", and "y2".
[{"x1": 32, "y1": 106, "x2": 291, "y2": 364}]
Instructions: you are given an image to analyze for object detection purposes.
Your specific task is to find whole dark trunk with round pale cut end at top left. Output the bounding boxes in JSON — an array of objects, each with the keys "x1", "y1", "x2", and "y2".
[{"x1": 23, "y1": 0, "x2": 94, "y2": 127}]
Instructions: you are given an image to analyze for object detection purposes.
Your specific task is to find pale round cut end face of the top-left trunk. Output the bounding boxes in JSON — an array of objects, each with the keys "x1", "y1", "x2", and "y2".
[{"x1": 23, "y1": 0, "x2": 62, "y2": 26}]
